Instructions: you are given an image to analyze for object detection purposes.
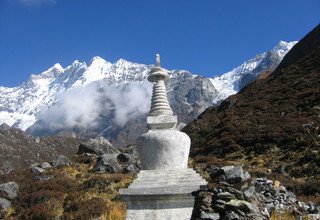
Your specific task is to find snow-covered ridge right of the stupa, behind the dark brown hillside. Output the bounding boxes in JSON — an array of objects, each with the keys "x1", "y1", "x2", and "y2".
[{"x1": 211, "y1": 41, "x2": 298, "y2": 101}]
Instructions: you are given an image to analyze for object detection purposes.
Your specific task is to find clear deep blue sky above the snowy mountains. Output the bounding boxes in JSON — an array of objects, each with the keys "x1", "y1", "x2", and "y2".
[{"x1": 0, "y1": 0, "x2": 320, "y2": 87}]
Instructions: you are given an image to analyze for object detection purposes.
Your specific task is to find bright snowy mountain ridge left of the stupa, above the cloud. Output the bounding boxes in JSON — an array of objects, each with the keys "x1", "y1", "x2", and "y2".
[{"x1": 0, "y1": 57, "x2": 150, "y2": 130}]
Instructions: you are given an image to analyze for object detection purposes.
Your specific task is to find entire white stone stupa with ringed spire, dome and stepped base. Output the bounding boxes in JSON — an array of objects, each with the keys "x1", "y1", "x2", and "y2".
[{"x1": 120, "y1": 54, "x2": 207, "y2": 220}]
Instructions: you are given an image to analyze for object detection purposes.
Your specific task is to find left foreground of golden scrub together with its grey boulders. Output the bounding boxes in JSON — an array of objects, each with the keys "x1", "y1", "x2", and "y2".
[{"x1": 0, "y1": 137, "x2": 140, "y2": 220}]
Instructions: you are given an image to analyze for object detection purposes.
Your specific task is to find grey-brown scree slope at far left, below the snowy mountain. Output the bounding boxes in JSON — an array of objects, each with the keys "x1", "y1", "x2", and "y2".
[{"x1": 0, "y1": 124, "x2": 82, "y2": 174}]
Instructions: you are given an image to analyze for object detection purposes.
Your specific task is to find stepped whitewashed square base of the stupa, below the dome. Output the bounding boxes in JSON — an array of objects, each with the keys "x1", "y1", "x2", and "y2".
[{"x1": 120, "y1": 169, "x2": 207, "y2": 220}]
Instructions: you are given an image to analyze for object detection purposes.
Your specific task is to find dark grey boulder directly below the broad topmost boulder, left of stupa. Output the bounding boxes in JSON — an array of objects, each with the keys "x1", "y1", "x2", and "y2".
[{"x1": 94, "y1": 154, "x2": 121, "y2": 173}]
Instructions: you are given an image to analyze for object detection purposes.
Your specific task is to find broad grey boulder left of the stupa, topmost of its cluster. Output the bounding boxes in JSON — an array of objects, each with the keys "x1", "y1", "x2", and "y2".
[{"x1": 77, "y1": 137, "x2": 120, "y2": 156}]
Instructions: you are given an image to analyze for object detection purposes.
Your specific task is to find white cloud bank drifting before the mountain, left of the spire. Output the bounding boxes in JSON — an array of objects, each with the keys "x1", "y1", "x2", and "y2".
[{"x1": 39, "y1": 82, "x2": 152, "y2": 131}]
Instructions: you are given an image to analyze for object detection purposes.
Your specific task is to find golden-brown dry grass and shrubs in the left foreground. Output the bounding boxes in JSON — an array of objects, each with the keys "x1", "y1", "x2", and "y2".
[{"x1": 1, "y1": 156, "x2": 134, "y2": 220}]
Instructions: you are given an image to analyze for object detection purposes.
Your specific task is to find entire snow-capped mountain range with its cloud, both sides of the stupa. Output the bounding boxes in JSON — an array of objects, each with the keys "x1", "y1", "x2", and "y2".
[{"x1": 0, "y1": 41, "x2": 296, "y2": 144}]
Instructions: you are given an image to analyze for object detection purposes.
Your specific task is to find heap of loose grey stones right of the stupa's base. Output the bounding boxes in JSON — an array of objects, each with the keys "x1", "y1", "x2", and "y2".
[{"x1": 191, "y1": 166, "x2": 320, "y2": 220}]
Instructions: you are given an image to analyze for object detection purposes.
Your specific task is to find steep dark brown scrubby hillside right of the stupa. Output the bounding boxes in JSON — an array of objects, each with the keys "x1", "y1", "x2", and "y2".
[{"x1": 184, "y1": 26, "x2": 320, "y2": 199}]
